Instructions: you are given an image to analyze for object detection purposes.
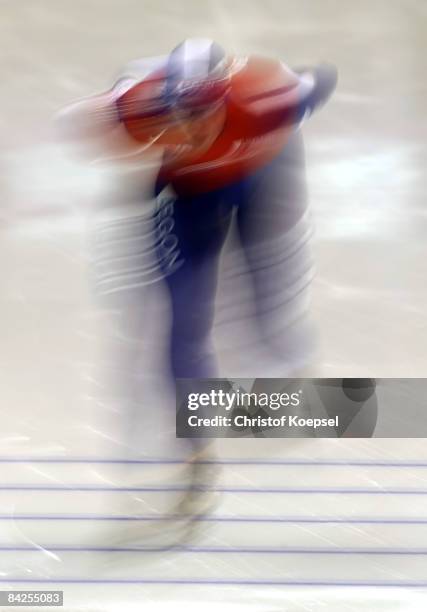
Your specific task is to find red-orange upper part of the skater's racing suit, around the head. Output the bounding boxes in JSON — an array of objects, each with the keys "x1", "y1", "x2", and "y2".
[{"x1": 117, "y1": 57, "x2": 306, "y2": 194}]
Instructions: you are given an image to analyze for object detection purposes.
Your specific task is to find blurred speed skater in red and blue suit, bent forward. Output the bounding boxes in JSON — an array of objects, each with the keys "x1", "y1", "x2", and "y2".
[{"x1": 56, "y1": 39, "x2": 337, "y2": 544}]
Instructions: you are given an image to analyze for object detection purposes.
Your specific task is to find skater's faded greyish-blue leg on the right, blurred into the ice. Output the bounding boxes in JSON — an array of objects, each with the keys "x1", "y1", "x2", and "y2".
[{"x1": 237, "y1": 132, "x2": 313, "y2": 373}]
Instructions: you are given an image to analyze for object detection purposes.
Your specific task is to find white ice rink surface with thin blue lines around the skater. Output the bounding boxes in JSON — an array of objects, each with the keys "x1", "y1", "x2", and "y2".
[{"x1": 0, "y1": 0, "x2": 427, "y2": 612}]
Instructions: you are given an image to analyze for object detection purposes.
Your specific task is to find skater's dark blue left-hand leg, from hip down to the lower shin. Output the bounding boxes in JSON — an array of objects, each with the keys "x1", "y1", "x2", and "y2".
[{"x1": 156, "y1": 190, "x2": 232, "y2": 538}]
